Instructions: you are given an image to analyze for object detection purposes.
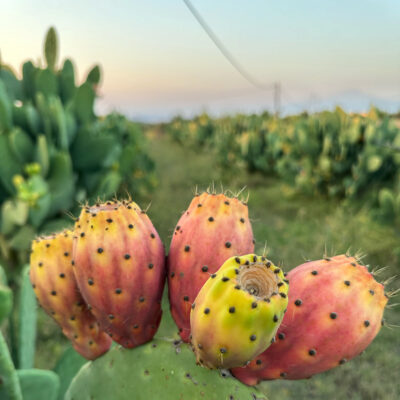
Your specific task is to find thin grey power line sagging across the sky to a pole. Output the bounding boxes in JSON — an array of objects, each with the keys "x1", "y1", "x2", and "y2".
[{"x1": 183, "y1": 0, "x2": 275, "y2": 90}]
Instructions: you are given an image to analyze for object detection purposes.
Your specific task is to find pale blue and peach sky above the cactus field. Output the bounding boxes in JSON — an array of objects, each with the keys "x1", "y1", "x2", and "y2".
[{"x1": 0, "y1": 0, "x2": 400, "y2": 121}]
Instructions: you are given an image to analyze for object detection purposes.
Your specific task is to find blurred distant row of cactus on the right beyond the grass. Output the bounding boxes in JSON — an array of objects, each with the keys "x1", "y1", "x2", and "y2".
[{"x1": 162, "y1": 108, "x2": 400, "y2": 220}]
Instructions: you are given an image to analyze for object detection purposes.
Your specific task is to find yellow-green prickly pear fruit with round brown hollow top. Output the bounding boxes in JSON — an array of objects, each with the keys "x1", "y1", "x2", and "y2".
[{"x1": 190, "y1": 254, "x2": 288, "y2": 369}]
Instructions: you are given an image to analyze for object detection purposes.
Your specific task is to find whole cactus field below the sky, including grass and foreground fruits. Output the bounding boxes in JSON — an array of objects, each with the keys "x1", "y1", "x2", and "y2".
[{"x1": 0, "y1": 28, "x2": 400, "y2": 400}]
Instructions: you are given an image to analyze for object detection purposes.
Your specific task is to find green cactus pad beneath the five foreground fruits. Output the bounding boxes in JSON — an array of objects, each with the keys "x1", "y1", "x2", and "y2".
[{"x1": 65, "y1": 340, "x2": 266, "y2": 400}]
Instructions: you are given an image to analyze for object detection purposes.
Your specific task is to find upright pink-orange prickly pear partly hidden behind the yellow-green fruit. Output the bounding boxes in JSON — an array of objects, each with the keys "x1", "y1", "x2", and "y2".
[{"x1": 168, "y1": 193, "x2": 254, "y2": 342}]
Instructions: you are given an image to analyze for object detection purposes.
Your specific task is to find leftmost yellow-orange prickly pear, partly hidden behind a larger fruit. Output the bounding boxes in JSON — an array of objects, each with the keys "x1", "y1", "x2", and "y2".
[{"x1": 30, "y1": 230, "x2": 111, "y2": 360}]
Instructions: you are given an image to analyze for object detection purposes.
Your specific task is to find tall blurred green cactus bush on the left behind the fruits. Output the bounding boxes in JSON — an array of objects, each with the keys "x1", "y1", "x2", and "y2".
[{"x1": 0, "y1": 28, "x2": 155, "y2": 272}]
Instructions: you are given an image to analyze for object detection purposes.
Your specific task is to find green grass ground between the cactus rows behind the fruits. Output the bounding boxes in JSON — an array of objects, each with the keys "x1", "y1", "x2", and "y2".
[{"x1": 37, "y1": 134, "x2": 400, "y2": 400}]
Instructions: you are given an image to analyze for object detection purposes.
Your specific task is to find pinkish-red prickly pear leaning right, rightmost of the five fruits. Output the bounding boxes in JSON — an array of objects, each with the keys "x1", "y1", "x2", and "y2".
[{"x1": 232, "y1": 255, "x2": 387, "y2": 385}]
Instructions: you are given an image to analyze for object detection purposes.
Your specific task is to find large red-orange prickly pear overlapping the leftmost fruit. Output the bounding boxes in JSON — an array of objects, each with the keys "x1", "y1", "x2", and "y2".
[{"x1": 74, "y1": 201, "x2": 166, "y2": 348}]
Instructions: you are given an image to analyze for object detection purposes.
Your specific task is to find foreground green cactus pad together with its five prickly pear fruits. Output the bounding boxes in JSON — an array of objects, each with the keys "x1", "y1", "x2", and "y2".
[{"x1": 0, "y1": 192, "x2": 390, "y2": 400}]
